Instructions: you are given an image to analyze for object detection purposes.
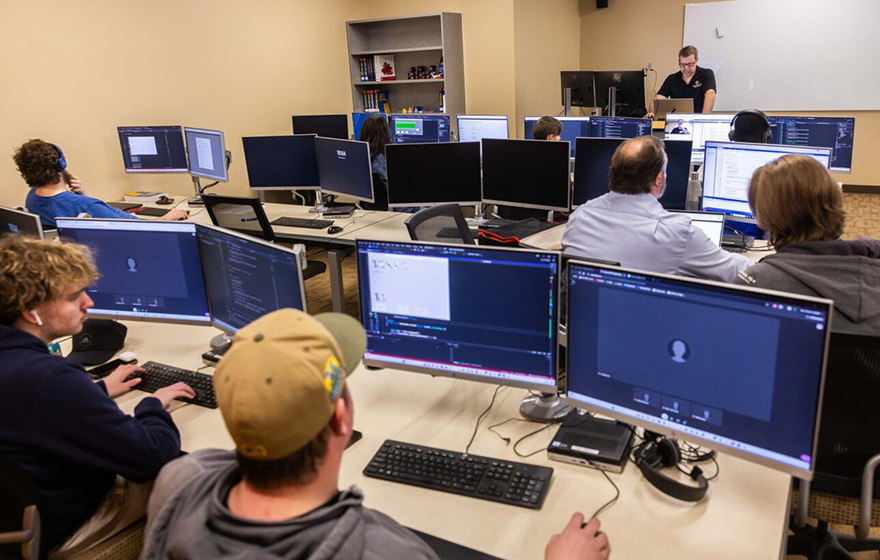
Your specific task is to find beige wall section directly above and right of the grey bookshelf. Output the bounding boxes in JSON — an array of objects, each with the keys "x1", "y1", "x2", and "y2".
[{"x1": 366, "y1": 0, "x2": 516, "y2": 136}]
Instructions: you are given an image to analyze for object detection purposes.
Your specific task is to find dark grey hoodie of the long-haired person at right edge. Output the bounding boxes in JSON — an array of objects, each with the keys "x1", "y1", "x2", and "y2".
[{"x1": 733, "y1": 238, "x2": 880, "y2": 336}]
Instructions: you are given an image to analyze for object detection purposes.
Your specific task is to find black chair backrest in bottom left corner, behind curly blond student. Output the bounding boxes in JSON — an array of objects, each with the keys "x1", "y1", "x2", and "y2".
[{"x1": 0, "y1": 457, "x2": 47, "y2": 560}]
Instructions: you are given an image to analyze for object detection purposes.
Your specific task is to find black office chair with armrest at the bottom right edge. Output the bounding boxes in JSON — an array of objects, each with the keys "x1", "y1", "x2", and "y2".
[{"x1": 787, "y1": 333, "x2": 880, "y2": 560}]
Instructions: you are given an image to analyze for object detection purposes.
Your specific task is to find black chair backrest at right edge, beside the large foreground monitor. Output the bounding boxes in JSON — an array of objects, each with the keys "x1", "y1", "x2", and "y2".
[{"x1": 811, "y1": 333, "x2": 880, "y2": 498}]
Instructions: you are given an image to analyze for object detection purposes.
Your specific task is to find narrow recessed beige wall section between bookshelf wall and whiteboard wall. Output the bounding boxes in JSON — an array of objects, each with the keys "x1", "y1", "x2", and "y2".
[{"x1": 511, "y1": 0, "x2": 581, "y2": 138}]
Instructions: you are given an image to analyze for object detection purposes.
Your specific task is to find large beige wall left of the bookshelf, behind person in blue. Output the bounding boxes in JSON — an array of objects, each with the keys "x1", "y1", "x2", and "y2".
[{"x1": 0, "y1": 0, "x2": 366, "y2": 205}]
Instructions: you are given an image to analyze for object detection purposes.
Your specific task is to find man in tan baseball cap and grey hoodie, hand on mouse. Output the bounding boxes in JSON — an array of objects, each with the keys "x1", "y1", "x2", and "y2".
[{"x1": 141, "y1": 309, "x2": 608, "y2": 560}]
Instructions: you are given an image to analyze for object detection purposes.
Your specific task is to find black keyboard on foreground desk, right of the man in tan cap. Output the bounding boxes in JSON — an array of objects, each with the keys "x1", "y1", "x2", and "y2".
[{"x1": 364, "y1": 439, "x2": 553, "y2": 509}]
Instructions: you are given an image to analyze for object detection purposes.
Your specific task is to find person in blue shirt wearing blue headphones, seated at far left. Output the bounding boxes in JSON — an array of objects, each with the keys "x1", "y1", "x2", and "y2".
[{"x1": 12, "y1": 139, "x2": 187, "y2": 227}]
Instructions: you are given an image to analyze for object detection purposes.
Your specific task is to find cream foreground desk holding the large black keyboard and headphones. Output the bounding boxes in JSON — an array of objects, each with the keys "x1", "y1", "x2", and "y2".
[{"x1": 108, "y1": 322, "x2": 790, "y2": 560}]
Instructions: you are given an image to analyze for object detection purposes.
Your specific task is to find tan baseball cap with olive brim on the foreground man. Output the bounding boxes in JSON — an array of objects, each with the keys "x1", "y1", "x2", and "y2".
[{"x1": 214, "y1": 309, "x2": 367, "y2": 461}]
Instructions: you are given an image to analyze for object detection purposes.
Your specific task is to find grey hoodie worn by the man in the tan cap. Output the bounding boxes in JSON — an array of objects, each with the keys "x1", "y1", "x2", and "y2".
[{"x1": 141, "y1": 449, "x2": 437, "y2": 560}]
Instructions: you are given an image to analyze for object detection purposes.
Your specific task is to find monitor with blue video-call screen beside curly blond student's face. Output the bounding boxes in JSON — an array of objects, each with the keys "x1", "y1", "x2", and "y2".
[{"x1": 56, "y1": 218, "x2": 211, "y2": 325}]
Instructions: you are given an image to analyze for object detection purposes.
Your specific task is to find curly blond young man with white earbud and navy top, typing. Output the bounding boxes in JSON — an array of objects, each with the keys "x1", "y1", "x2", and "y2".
[{"x1": 0, "y1": 235, "x2": 195, "y2": 557}]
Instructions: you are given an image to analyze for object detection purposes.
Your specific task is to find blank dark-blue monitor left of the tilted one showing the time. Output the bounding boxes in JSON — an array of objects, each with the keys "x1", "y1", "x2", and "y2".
[{"x1": 241, "y1": 134, "x2": 321, "y2": 190}]
